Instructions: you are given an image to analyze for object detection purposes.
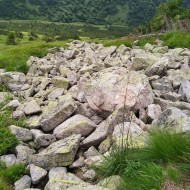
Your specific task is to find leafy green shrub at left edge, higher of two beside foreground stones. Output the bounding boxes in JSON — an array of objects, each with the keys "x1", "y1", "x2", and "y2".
[{"x1": 0, "y1": 128, "x2": 18, "y2": 156}]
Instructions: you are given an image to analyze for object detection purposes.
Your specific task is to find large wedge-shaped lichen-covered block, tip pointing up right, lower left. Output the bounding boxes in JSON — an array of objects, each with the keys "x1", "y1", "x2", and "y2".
[{"x1": 30, "y1": 135, "x2": 81, "y2": 170}]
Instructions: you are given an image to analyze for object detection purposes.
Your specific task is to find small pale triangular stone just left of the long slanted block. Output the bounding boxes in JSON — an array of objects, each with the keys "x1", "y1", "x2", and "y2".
[{"x1": 24, "y1": 100, "x2": 42, "y2": 115}]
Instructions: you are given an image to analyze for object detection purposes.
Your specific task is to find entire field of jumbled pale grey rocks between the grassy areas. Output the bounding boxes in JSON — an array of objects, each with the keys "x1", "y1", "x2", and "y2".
[{"x1": 0, "y1": 41, "x2": 190, "y2": 190}]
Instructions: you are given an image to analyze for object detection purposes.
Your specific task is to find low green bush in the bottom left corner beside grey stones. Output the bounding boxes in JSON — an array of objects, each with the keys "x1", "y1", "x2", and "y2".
[{"x1": 0, "y1": 164, "x2": 27, "y2": 184}]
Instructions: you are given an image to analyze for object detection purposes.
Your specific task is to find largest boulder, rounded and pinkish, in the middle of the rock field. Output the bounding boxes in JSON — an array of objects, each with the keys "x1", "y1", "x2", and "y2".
[{"x1": 79, "y1": 67, "x2": 153, "y2": 114}]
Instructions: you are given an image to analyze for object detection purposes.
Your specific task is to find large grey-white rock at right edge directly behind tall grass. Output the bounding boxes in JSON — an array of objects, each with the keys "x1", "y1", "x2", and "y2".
[{"x1": 152, "y1": 107, "x2": 190, "y2": 133}]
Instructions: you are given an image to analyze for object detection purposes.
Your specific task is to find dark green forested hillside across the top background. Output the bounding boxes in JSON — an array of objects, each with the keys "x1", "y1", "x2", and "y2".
[{"x1": 0, "y1": 0, "x2": 166, "y2": 26}]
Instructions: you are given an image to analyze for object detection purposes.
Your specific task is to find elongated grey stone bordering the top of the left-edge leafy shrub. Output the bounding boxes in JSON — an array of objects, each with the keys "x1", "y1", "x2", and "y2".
[{"x1": 9, "y1": 125, "x2": 32, "y2": 142}]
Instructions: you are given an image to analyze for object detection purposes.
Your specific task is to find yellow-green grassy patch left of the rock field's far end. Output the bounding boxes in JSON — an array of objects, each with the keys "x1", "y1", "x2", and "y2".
[{"x1": 0, "y1": 35, "x2": 66, "y2": 73}]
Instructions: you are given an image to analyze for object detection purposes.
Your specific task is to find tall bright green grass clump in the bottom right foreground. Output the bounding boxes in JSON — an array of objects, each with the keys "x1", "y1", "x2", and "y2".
[{"x1": 94, "y1": 130, "x2": 190, "y2": 190}]
